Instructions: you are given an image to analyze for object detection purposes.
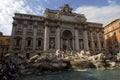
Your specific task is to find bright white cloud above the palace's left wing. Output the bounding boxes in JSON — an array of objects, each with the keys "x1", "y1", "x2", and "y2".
[{"x1": 0, "y1": 0, "x2": 42, "y2": 35}]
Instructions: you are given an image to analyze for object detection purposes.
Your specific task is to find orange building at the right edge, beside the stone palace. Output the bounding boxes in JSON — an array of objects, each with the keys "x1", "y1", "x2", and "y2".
[{"x1": 104, "y1": 18, "x2": 120, "y2": 54}]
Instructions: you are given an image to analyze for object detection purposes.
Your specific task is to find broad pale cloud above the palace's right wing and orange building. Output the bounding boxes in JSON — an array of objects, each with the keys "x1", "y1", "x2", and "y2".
[{"x1": 74, "y1": 5, "x2": 120, "y2": 26}]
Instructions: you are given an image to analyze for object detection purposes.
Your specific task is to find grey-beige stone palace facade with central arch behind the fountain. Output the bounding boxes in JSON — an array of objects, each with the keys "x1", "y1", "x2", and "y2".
[{"x1": 9, "y1": 4, "x2": 105, "y2": 58}]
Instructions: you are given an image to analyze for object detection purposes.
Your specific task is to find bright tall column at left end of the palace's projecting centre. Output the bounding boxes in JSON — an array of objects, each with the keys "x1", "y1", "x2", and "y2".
[{"x1": 44, "y1": 25, "x2": 49, "y2": 51}]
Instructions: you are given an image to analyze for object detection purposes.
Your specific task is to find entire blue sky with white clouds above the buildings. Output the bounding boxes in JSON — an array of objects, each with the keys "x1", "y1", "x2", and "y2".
[{"x1": 0, "y1": 0, "x2": 120, "y2": 35}]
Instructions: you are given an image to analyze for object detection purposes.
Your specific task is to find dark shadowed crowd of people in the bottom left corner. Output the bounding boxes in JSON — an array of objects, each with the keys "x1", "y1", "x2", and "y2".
[{"x1": 0, "y1": 61, "x2": 19, "y2": 80}]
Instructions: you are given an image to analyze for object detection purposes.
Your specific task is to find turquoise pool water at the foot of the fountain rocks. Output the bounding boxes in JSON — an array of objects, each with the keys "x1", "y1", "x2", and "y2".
[{"x1": 20, "y1": 67, "x2": 120, "y2": 80}]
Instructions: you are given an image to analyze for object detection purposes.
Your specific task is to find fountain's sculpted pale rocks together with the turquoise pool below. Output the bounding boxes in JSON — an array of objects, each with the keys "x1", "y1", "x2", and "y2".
[{"x1": 1, "y1": 51, "x2": 120, "y2": 80}]
